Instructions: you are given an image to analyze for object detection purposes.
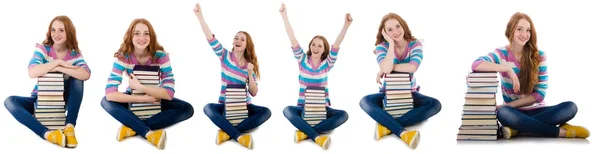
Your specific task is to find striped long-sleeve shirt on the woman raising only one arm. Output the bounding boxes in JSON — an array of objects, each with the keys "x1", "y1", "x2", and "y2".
[{"x1": 208, "y1": 35, "x2": 258, "y2": 104}]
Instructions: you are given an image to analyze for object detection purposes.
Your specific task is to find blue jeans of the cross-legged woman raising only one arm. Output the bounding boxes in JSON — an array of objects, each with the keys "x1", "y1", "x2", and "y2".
[{"x1": 204, "y1": 103, "x2": 271, "y2": 141}]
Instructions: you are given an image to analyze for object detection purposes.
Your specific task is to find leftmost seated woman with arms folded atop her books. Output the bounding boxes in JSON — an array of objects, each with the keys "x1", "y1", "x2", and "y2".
[{"x1": 4, "y1": 16, "x2": 90, "y2": 148}]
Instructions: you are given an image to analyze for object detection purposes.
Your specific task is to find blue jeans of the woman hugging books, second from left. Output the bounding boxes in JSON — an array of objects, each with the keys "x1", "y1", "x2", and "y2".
[{"x1": 100, "y1": 97, "x2": 194, "y2": 138}]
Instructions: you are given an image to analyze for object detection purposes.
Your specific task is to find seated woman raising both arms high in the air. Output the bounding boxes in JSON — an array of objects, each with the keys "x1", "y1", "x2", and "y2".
[{"x1": 279, "y1": 4, "x2": 352, "y2": 149}]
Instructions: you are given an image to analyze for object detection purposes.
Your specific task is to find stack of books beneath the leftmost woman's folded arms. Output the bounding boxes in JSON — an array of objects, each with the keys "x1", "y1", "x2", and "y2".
[{"x1": 34, "y1": 72, "x2": 67, "y2": 130}]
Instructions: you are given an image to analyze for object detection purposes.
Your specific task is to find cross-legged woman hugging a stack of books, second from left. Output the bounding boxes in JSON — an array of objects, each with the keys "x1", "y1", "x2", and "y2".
[{"x1": 101, "y1": 18, "x2": 194, "y2": 150}]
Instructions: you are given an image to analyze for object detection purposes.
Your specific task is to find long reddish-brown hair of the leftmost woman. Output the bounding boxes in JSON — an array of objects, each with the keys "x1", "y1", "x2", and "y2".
[{"x1": 42, "y1": 15, "x2": 81, "y2": 53}]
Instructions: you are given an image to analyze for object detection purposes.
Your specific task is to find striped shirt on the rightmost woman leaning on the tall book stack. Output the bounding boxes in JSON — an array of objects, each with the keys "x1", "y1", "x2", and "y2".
[{"x1": 471, "y1": 46, "x2": 548, "y2": 110}]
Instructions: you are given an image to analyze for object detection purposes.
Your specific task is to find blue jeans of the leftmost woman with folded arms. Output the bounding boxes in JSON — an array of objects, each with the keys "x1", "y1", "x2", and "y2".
[{"x1": 4, "y1": 77, "x2": 83, "y2": 138}]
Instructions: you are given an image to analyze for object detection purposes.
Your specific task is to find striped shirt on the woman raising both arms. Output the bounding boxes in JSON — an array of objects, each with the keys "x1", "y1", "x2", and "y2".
[{"x1": 292, "y1": 45, "x2": 339, "y2": 106}]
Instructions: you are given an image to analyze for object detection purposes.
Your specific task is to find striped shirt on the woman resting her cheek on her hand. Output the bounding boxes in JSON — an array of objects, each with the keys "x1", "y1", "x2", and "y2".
[{"x1": 375, "y1": 40, "x2": 423, "y2": 92}]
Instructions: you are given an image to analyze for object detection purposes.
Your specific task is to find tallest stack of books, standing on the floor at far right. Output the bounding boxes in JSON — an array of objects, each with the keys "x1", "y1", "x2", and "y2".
[{"x1": 457, "y1": 72, "x2": 499, "y2": 141}]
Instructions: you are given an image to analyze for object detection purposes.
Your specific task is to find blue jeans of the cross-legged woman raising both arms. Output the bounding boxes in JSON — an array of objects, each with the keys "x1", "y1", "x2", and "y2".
[{"x1": 283, "y1": 106, "x2": 348, "y2": 141}]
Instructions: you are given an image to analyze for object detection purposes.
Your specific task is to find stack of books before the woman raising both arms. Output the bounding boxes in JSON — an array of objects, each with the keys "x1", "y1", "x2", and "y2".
[{"x1": 302, "y1": 86, "x2": 327, "y2": 127}]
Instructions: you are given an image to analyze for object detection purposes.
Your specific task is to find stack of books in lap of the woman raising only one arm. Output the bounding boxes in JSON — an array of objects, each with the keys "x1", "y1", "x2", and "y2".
[{"x1": 224, "y1": 84, "x2": 248, "y2": 126}]
